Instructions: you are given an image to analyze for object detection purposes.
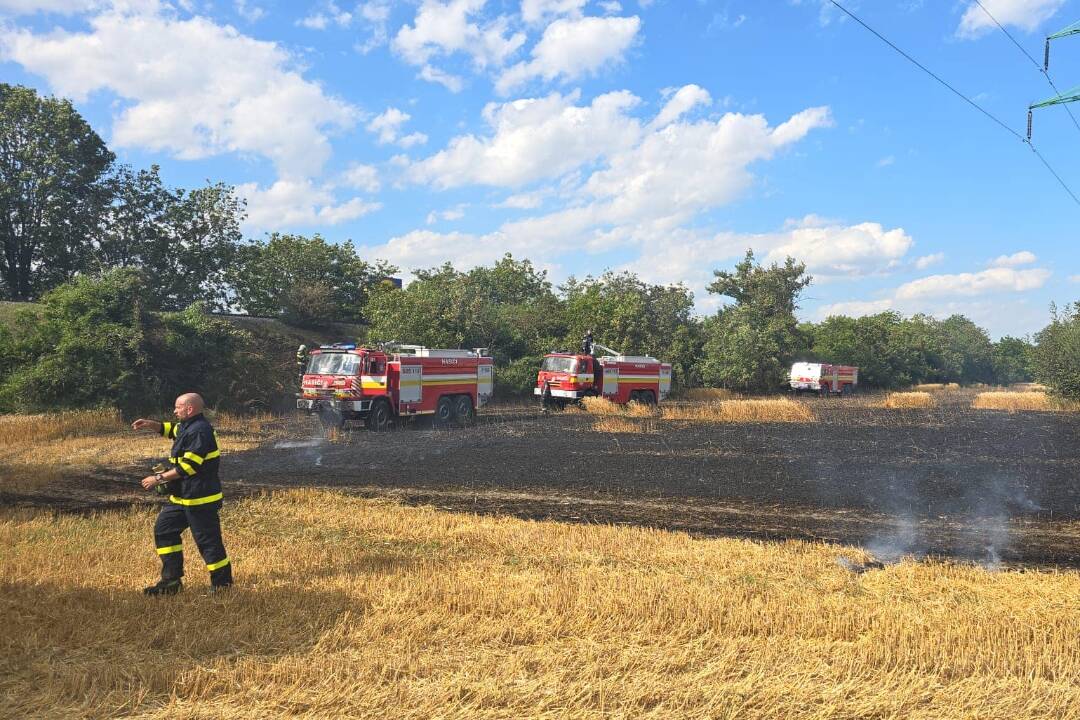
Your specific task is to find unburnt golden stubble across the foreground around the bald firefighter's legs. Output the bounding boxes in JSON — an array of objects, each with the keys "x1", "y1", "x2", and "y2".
[{"x1": 0, "y1": 491, "x2": 1080, "y2": 720}]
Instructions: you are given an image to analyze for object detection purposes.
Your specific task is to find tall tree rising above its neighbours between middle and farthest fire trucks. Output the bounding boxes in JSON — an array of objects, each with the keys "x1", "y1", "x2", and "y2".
[{"x1": 701, "y1": 250, "x2": 812, "y2": 392}]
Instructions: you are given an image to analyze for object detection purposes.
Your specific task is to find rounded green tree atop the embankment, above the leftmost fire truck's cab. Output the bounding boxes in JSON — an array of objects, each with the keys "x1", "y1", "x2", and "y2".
[{"x1": 229, "y1": 233, "x2": 396, "y2": 324}]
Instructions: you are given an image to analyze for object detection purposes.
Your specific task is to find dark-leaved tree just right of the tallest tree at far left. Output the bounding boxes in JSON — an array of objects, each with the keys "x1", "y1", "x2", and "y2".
[{"x1": 93, "y1": 165, "x2": 244, "y2": 310}]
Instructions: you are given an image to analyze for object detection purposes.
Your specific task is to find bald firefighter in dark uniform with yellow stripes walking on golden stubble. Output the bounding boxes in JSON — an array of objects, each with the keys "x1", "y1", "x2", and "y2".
[{"x1": 132, "y1": 393, "x2": 232, "y2": 595}]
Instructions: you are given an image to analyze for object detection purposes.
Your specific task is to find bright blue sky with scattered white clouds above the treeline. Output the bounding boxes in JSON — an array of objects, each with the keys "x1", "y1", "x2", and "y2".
[{"x1": 0, "y1": 0, "x2": 1080, "y2": 337}]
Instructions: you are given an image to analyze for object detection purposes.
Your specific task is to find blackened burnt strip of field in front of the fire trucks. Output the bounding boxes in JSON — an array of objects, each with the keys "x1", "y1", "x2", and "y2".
[{"x1": 2, "y1": 393, "x2": 1080, "y2": 568}]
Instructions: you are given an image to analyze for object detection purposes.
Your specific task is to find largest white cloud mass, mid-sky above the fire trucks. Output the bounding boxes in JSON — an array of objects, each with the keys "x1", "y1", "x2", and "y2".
[{"x1": 369, "y1": 92, "x2": 833, "y2": 293}]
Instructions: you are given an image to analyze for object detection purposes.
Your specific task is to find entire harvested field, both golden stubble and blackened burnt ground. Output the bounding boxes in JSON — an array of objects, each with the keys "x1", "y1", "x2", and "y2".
[{"x1": 0, "y1": 389, "x2": 1080, "y2": 719}]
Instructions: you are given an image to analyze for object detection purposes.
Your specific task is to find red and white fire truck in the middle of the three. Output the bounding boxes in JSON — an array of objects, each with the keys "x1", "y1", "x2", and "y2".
[{"x1": 532, "y1": 343, "x2": 672, "y2": 405}]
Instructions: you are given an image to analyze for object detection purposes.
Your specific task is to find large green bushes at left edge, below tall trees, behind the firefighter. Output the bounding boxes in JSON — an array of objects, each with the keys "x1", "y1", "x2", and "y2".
[{"x1": 0, "y1": 268, "x2": 282, "y2": 412}]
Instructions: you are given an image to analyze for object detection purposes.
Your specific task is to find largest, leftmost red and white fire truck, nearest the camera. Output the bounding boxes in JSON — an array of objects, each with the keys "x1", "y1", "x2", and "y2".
[{"x1": 296, "y1": 343, "x2": 495, "y2": 430}]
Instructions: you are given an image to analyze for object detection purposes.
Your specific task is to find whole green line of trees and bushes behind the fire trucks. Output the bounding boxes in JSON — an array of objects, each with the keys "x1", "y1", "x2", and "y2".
[{"x1": 0, "y1": 84, "x2": 1080, "y2": 411}]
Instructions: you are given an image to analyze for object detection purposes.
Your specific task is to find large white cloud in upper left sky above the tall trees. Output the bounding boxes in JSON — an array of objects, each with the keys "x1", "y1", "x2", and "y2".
[{"x1": 0, "y1": 11, "x2": 357, "y2": 176}]
